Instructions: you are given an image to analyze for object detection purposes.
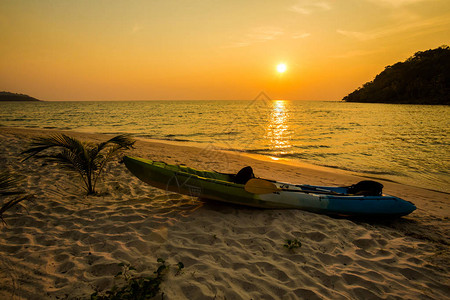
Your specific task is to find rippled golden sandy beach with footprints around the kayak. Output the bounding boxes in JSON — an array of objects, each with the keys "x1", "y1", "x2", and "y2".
[{"x1": 0, "y1": 127, "x2": 450, "y2": 299}]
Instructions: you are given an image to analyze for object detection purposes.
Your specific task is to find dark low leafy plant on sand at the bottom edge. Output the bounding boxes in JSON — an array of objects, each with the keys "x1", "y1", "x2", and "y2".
[{"x1": 91, "y1": 258, "x2": 184, "y2": 300}]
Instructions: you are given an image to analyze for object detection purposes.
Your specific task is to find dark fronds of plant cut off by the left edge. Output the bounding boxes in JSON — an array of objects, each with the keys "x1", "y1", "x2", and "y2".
[{"x1": 0, "y1": 171, "x2": 33, "y2": 225}]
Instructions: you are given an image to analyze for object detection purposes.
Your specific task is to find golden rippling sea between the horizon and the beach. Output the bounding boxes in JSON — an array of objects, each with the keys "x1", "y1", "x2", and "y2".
[{"x1": 0, "y1": 100, "x2": 450, "y2": 192}]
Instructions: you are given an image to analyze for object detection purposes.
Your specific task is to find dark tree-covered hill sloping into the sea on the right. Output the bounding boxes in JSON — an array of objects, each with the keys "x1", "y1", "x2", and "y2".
[{"x1": 342, "y1": 46, "x2": 450, "y2": 105}]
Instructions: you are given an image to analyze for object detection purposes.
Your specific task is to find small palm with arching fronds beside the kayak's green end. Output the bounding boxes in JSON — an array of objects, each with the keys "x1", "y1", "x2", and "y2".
[{"x1": 22, "y1": 134, "x2": 135, "y2": 195}]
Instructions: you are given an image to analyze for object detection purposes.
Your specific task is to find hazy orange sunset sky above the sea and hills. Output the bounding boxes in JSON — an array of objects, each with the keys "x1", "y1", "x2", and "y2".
[{"x1": 0, "y1": 0, "x2": 450, "y2": 101}]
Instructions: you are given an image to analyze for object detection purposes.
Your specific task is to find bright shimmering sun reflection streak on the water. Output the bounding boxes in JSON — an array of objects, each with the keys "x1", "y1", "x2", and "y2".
[{"x1": 265, "y1": 100, "x2": 292, "y2": 155}]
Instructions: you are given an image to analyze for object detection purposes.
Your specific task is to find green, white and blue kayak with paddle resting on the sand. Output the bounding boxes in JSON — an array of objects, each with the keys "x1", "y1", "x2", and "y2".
[{"x1": 123, "y1": 156, "x2": 416, "y2": 217}]
